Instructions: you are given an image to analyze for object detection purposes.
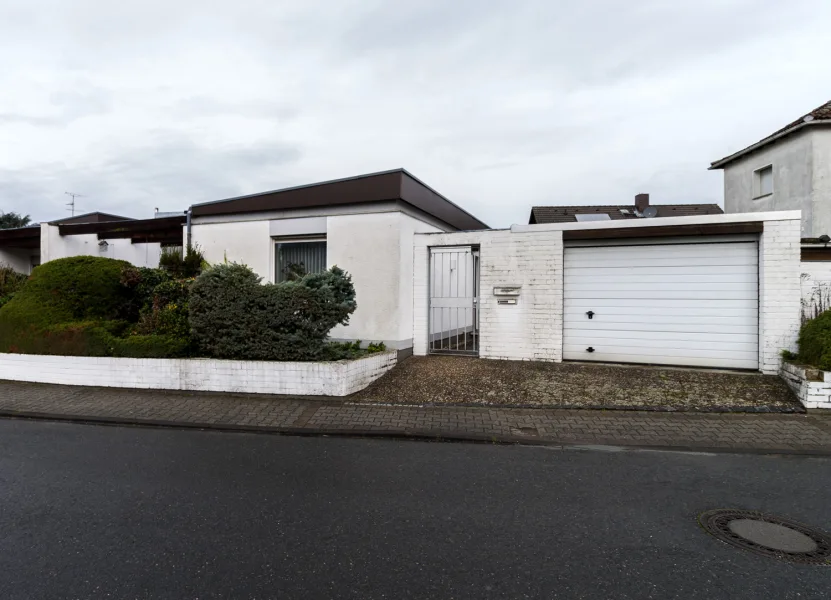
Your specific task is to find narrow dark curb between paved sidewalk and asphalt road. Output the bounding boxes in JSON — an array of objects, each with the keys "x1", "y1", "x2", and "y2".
[{"x1": 0, "y1": 410, "x2": 831, "y2": 457}]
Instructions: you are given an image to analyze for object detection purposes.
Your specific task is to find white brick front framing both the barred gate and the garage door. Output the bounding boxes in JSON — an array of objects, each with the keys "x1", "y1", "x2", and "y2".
[{"x1": 413, "y1": 212, "x2": 800, "y2": 374}]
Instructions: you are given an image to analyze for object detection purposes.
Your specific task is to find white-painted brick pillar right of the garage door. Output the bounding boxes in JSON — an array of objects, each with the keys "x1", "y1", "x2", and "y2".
[{"x1": 759, "y1": 219, "x2": 801, "y2": 375}]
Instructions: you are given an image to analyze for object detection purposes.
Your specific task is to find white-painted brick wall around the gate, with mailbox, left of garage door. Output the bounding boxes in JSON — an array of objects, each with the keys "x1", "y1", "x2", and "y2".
[{"x1": 413, "y1": 230, "x2": 563, "y2": 361}]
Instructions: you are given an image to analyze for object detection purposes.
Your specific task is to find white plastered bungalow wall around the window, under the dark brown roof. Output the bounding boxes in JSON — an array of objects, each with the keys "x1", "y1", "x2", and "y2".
[{"x1": 191, "y1": 202, "x2": 446, "y2": 350}]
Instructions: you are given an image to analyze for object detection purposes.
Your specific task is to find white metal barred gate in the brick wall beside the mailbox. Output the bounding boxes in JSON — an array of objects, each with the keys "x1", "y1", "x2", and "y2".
[{"x1": 428, "y1": 246, "x2": 479, "y2": 355}]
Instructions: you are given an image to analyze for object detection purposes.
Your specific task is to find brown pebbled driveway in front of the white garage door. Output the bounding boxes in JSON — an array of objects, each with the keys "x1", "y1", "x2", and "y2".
[{"x1": 350, "y1": 356, "x2": 803, "y2": 412}]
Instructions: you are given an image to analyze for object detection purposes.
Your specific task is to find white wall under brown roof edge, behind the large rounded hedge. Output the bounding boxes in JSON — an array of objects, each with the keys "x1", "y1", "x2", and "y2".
[{"x1": 40, "y1": 223, "x2": 161, "y2": 267}]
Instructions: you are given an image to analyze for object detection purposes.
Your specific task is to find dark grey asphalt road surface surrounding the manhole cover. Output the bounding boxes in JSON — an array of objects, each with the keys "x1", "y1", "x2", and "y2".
[{"x1": 0, "y1": 421, "x2": 831, "y2": 600}]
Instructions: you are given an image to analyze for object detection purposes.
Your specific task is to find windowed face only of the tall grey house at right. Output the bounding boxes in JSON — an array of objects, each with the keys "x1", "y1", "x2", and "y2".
[{"x1": 724, "y1": 130, "x2": 814, "y2": 237}]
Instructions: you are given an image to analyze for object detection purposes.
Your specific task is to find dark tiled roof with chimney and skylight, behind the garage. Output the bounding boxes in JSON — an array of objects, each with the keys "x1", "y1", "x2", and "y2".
[{"x1": 528, "y1": 194, "x2": 723, "y2": 225}]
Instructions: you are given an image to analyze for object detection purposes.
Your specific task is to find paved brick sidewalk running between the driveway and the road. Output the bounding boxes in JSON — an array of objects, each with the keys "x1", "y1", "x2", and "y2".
[{"x1": 0, "y1": 381, "x2": 831, "y2": 455}]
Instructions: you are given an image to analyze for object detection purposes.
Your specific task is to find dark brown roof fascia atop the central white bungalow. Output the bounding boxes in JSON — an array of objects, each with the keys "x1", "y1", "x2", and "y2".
[{"x1": 191, "y1": 169, "x2": 488, "y2": 230}]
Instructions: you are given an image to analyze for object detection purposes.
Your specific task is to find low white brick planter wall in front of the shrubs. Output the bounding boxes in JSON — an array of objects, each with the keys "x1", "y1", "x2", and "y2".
[{"x1": 0, "y1": 352, "x2": 397, "y2": 396}]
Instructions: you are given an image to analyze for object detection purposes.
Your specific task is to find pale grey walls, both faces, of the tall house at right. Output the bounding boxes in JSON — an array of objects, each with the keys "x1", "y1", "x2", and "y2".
[{"x1": 722, "y1": 126, "x2": 831, "y2": 238}]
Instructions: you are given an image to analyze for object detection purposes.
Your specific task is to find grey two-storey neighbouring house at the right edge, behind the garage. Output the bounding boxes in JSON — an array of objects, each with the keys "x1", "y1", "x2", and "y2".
[{"x1": 710, "y1": 101, "x2": 831, "y2": 318}]
